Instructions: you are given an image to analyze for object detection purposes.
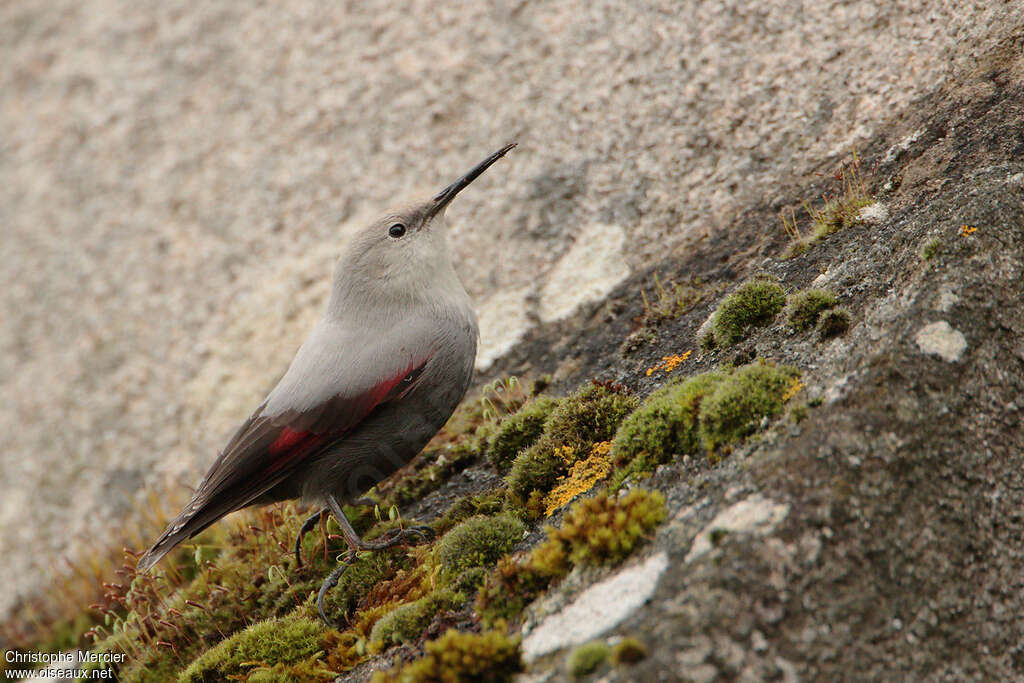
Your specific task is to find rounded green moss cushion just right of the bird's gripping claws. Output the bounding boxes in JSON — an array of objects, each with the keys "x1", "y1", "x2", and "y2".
[{"x1": 436, "y1": 515, "x2": 525, "y2": 577}]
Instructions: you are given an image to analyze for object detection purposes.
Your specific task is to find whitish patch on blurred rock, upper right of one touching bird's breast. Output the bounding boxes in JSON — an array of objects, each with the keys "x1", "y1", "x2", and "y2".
[{"x1": 540, "y1": 223, "x2": 630, "y2": 323}]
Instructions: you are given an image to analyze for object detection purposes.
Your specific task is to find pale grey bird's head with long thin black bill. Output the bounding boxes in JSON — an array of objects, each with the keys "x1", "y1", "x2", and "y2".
[{"x1": 334, "y1": 143, "x2": 515, "y2": 313}]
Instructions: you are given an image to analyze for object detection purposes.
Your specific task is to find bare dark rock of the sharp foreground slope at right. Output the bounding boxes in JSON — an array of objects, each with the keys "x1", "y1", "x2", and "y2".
[{"x1": 481, "y1": 38, "x2": 1024, "y2": 681}]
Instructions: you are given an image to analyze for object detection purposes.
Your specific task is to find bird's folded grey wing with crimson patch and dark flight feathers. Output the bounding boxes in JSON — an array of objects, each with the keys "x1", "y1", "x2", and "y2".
[{"x1": 138, "y1": 326, "x2": 432, "y2": 569}]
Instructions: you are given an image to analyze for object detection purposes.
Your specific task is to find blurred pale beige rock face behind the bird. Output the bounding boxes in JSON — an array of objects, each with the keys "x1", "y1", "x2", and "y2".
[{"x1": 0, "y1": 0, "x2": 1022, "y2": 611}]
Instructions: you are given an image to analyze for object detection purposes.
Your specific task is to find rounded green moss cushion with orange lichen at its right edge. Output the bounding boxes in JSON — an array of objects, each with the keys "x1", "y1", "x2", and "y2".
[{"x1": 699, "y1": 362, "x2": 800, "y2": 451}]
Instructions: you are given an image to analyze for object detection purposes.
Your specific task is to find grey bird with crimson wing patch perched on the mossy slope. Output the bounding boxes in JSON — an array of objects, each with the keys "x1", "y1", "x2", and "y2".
[{"x1": 138, "y1": 143, "x2": 515, "y2": 622}]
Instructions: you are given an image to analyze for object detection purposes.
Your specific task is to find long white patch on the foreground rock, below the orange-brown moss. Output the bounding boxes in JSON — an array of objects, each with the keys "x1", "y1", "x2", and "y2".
[{"x1": 522, "y1": 553, "x2": 669, "y2": 661}]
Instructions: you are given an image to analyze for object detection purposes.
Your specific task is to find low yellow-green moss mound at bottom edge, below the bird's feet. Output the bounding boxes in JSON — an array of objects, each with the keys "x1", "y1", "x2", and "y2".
[{"x1": 178, "y1": 617, "x2": 333, "y2": 683}]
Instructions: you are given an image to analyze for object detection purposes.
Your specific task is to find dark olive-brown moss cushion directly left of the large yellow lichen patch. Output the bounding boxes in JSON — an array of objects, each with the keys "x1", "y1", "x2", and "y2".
[{"x1": 506, "y1": 382, "x2": 637, "y2": 502}]
